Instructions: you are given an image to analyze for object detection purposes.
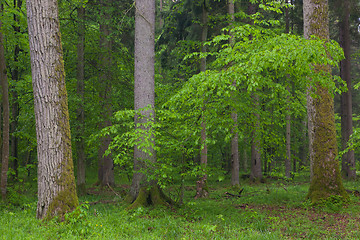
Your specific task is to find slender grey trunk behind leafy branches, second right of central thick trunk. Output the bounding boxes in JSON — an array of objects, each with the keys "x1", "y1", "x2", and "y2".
[{"x1": 228, "y1": 0, "x2": 240, "y2": 186}]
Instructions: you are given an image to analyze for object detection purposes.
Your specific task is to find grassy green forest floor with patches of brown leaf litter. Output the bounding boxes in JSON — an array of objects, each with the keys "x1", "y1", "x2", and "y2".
[{"x1": 0, "y1": 173, "x2": 360, "y2": 240}]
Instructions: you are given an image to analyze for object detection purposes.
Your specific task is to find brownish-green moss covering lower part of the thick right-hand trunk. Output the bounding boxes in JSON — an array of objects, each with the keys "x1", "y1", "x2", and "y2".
[{"x1": 307, "y1": 82, "x2": 348, "y2": 203}]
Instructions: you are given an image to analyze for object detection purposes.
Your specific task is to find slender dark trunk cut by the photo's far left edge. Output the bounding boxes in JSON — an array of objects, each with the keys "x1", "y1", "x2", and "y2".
[{"x1": 0, "y1": 12, "x2": 10, "y2": 200}]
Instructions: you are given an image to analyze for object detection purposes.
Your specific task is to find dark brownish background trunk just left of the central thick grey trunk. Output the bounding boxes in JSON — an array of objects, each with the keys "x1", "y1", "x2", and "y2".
[{"x1": 98, "y1": 0, "x2": 115, "y2": 186}]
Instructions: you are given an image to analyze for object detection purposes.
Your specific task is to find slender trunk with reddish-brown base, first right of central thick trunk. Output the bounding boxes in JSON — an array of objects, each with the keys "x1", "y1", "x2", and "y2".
[{"x1": 195, "y1": 1, "x2": 209, "y2": 198}]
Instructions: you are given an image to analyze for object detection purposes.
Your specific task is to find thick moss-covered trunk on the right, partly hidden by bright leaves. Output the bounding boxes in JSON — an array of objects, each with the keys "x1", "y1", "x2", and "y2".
[{"x1": 304, "y1": 0, "x2": 347, "y2": 203}]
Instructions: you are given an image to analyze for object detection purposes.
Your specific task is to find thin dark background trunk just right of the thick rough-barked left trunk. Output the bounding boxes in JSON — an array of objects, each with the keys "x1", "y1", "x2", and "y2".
[{"x1": 76, "y1": 6, "x2": 86, "y2": 194}]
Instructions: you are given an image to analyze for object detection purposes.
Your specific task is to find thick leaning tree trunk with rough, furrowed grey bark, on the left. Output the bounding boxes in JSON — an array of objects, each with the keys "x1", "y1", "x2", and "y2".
[{"x1": 27, "y1": 0, "x2": 78, "y2": 219}]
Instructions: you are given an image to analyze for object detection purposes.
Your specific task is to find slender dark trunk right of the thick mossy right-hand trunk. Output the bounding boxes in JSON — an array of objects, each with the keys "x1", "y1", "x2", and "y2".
[{"x1": 339, "y1": 0, "x2": 356, "y2": 179}]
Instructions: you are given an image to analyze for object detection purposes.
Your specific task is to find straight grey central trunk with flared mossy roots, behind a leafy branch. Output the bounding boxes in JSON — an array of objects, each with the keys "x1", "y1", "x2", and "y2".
[{"x1": 126, "y1": 0, "x2": 172, "y2": 209}]
